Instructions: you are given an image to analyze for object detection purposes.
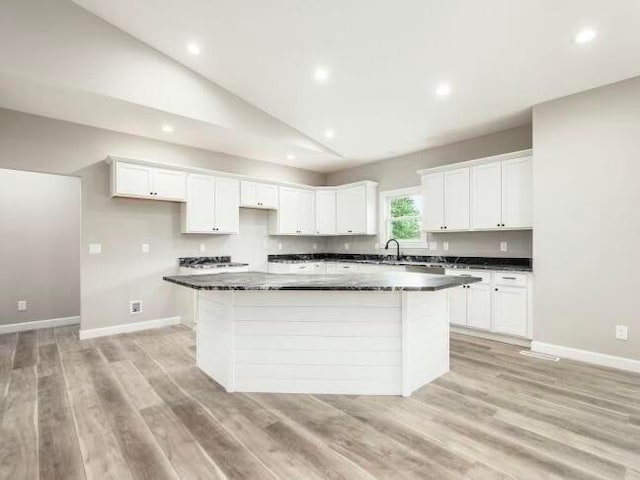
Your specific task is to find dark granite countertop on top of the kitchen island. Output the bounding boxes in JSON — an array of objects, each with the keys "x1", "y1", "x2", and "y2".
[{"x1": 163, "y1": 272, "x2": 481, "y2": 292}]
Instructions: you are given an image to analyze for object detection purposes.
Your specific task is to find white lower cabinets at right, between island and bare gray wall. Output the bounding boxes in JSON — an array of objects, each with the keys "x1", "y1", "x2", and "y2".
[{"x1": 446, "y1": 270, "x2": 531, "y2": 337}]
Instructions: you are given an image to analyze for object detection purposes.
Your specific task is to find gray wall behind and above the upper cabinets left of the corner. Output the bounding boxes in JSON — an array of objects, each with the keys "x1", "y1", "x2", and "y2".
[{"x1": 0, "y1": 109, "x2": 324, "y2": 329}]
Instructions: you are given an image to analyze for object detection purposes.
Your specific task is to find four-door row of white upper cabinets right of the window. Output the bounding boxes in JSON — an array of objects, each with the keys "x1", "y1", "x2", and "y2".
[{"x1": 418, "y1": 151, "x2": 533, "y2": 232}]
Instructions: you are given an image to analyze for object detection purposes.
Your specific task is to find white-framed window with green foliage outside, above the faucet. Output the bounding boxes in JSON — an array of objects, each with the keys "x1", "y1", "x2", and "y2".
[{"x1": 380, "y1": 187, "x2": 426, "y2": 248}]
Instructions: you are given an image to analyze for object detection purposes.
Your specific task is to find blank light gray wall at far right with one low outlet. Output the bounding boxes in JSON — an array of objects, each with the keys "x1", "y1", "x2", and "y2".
[{"x1": 533, "y1": 78, "x2": 640, "y2": 359}]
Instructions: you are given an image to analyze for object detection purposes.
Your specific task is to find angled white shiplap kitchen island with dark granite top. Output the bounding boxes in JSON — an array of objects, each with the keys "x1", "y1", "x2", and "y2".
[{"x1": 164, "y1": 272, "x2": 480, "y2": 396}]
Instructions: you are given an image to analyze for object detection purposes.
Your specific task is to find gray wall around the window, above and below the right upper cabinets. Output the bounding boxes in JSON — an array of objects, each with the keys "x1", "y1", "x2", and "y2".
[{"x1": 327, "y1": 126, "x2": 532, "y2": 258}]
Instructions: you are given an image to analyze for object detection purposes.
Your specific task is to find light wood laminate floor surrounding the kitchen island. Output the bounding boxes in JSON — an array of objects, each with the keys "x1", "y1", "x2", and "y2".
[{"x1": 0, "y1": 326, "x2": 640, "y2": 480}]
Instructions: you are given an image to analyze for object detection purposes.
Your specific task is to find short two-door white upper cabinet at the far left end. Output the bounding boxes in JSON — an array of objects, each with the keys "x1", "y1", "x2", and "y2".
[{"x1": 111, "y1": 162, "x2": 187, "y2": 202}]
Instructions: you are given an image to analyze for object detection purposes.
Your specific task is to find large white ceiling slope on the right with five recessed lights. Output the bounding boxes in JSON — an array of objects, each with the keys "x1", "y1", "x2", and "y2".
[{"x1": 74, "y1": 0, "x2": 640, "y2": 167}]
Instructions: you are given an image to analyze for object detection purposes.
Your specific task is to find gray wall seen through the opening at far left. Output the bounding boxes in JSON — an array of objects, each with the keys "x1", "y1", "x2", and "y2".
[{"x1": 0, "y1": 169, "x2": 80, "y2": 325}]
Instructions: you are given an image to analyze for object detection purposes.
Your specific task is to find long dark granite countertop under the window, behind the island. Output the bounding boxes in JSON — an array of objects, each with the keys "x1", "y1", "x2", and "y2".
[{"x1": 268, "y1": 253, "x2": 533, "y2": 272}]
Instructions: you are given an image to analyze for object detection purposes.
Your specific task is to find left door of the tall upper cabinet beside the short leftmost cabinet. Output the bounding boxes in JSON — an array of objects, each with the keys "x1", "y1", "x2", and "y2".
[{"x1": 185, "y1": 174, "x2": 215, "y2": 233}]
